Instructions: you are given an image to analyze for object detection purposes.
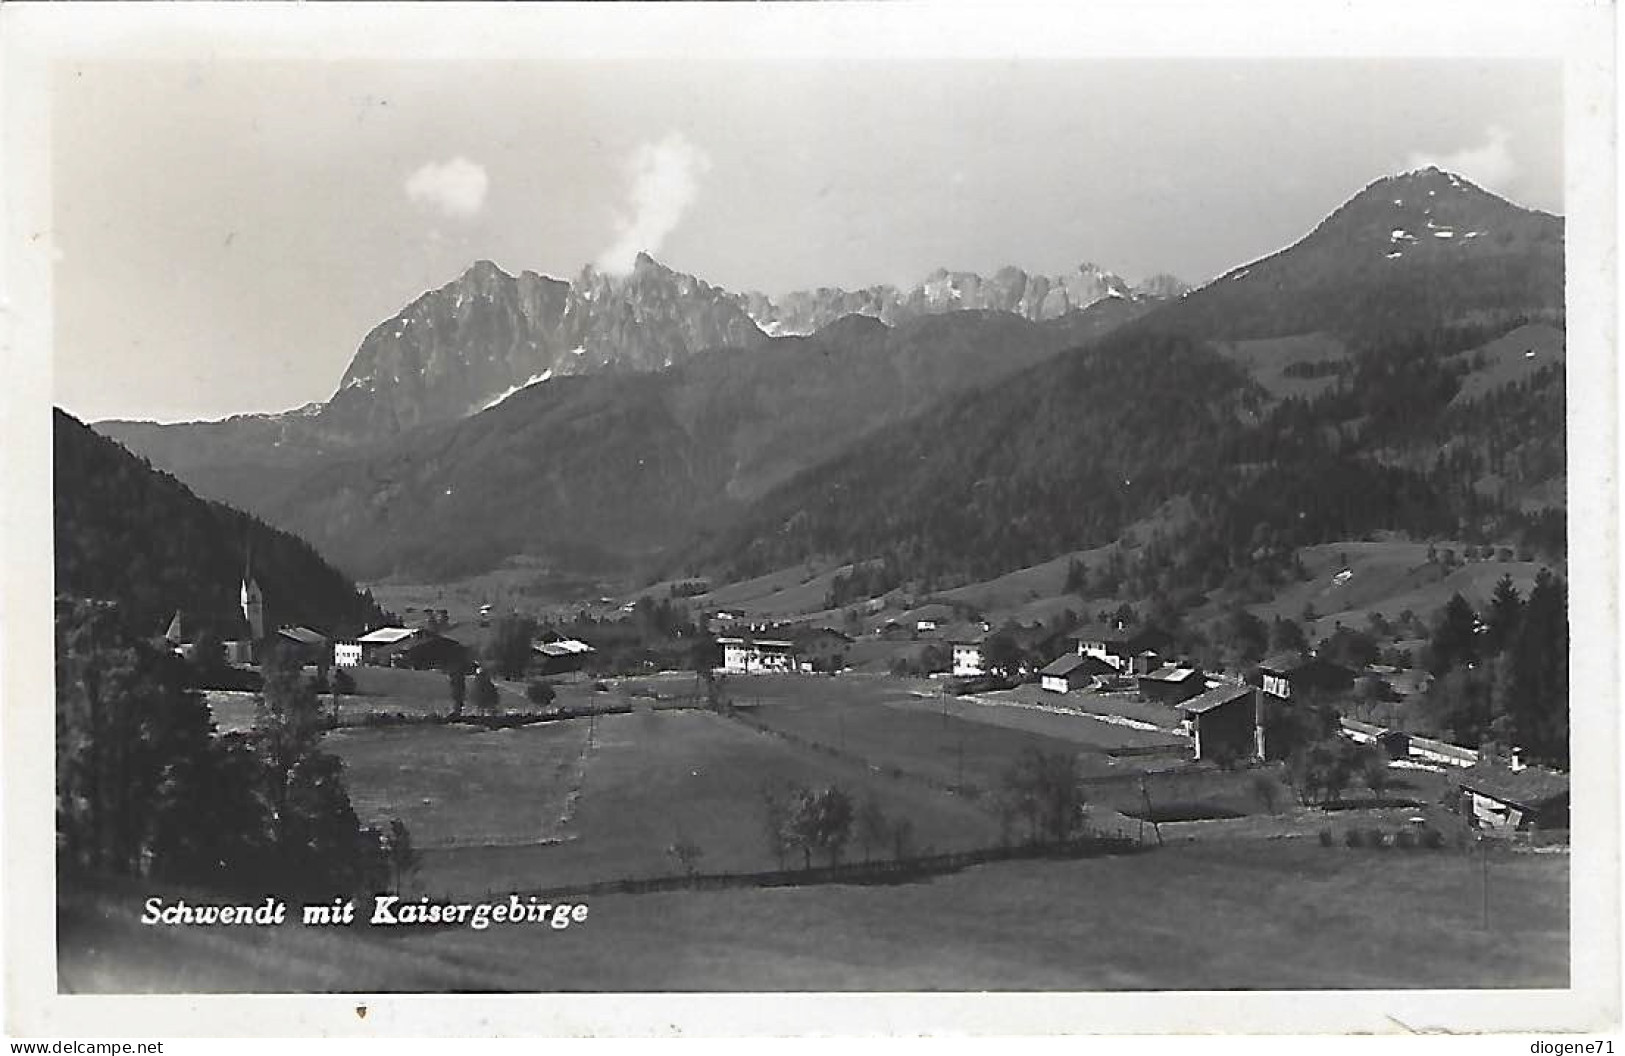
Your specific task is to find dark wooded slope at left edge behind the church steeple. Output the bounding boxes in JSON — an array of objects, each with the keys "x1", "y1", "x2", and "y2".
[{"x1": 54, "y1": 409, "x2": 380, "y2": 635}]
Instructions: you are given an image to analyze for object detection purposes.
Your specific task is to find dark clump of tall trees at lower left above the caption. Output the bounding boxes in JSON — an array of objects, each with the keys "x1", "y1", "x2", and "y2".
[{"x1": 57, "y1": 598, "x2": 416, "y2": 897}]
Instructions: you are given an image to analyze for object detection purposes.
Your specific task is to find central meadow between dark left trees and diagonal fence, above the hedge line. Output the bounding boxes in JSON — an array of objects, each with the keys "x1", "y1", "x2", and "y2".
[{"x1": 403, "y1": 710, "x2": 998, "y2": 894}]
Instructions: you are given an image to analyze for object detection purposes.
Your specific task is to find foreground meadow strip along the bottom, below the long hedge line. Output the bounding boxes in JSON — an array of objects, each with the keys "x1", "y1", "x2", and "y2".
[{"x1": 59, "y1": 838, "x2": 1570, "y2": 991}]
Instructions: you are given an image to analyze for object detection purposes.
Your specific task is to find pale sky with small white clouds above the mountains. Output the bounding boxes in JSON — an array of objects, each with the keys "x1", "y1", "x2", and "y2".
[{"x1": 50, "y1": 54, "x2": 1563, "y2": 421}]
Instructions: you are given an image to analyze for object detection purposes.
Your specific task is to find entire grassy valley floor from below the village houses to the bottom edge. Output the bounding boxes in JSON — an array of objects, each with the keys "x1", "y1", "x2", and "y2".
[{"x1": 59, "y1": 673, "x2": 1570, "y2": 993}]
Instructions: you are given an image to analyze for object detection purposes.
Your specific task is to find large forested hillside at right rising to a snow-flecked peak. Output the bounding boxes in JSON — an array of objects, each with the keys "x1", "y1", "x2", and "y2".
[{"x1": 681, "y1": 171, "x2": 1565, "y2": 595}]
